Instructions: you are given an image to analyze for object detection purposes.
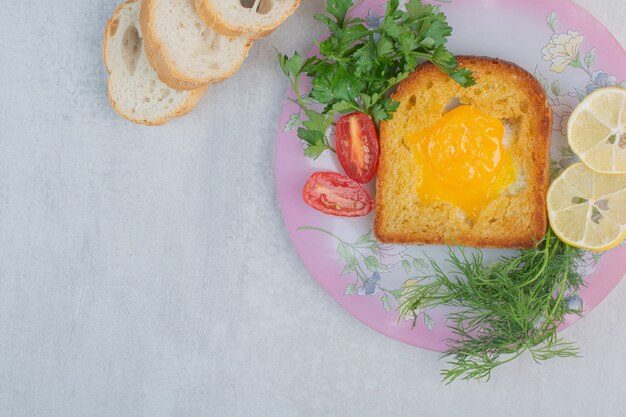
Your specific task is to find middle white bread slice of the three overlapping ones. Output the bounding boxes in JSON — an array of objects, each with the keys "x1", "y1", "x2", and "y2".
[{"x1": 139, "y1": 0, "x2": 252, "y2": 90}]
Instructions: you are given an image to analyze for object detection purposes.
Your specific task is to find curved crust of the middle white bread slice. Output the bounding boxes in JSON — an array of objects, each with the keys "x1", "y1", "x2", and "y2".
[{"x1": 139, "y1": 0, "x2": 252, "y2": 90}]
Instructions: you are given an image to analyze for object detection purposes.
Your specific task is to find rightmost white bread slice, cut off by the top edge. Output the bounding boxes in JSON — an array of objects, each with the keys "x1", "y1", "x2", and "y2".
[{"x1": 195, "y1": 0, "x2": 300, "y2": 39}]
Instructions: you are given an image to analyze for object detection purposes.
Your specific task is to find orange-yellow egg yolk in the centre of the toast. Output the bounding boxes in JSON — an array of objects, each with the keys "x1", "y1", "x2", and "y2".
[{"x1": 407, "y1": 105, "x2": 515, "y2": 222}]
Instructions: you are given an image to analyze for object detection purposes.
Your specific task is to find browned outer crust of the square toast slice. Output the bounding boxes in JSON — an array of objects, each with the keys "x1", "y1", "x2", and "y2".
[{"x1": 374, "y1": 56, "x2": 552, "y2": 248}]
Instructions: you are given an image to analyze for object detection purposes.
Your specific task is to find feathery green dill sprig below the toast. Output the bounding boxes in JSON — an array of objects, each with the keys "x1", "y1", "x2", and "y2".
[{"x1": 399, "y1": 230, "x2": 583, "y2": 384}]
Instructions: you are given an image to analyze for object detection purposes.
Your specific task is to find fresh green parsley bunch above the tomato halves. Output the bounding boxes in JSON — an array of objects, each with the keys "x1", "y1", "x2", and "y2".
[{"x1": 278, "y1": 0, "x2": 475, "y2": 158}]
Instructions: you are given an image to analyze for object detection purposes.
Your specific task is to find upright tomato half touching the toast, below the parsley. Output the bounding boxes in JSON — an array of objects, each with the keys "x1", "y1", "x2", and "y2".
[{"x1": 336, "y1": 113, "x2": 380, "y2": 184}]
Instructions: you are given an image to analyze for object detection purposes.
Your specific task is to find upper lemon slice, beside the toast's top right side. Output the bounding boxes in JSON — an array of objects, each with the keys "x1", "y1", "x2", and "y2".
[{"x1": 567, "y1": 87, "x2": 626, "y2": 174}]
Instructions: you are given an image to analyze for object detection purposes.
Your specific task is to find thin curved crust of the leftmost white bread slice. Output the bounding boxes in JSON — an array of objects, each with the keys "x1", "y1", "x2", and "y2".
[{"x1": 102, "y1": 0, "x2": 207, "y2": 126}]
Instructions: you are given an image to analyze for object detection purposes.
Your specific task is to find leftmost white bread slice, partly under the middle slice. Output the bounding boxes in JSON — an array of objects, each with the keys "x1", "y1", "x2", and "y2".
[{"x1": 103, "y1": 0, "x2": 206, "y2": 125}]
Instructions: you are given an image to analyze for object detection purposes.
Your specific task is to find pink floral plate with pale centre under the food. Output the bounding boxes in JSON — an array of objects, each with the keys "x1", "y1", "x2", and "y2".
[{"x1": 276, "y1": 0, "x2": 626, "y2": 351}]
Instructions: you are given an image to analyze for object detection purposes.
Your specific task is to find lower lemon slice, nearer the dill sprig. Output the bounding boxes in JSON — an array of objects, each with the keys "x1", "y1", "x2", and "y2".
[{"x1": 548, "y1": 162, "x2": 626, "y2": 251}]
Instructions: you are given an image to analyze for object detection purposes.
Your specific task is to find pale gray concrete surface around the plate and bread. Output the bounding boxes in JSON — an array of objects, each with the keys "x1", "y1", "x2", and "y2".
[{"x1": 0, "y1": 0, "x2": 626, "y2": 417}]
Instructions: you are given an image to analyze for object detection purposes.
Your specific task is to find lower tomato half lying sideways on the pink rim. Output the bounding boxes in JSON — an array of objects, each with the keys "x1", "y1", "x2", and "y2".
[{"x1": 302, "y1": 172, "x2": 374, "y2": 217}]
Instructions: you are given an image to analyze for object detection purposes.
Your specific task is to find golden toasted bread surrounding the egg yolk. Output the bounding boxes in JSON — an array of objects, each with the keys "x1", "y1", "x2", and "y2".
[{"x1": 374, "y1": 56, "x2": 552, "y2": 248}]
